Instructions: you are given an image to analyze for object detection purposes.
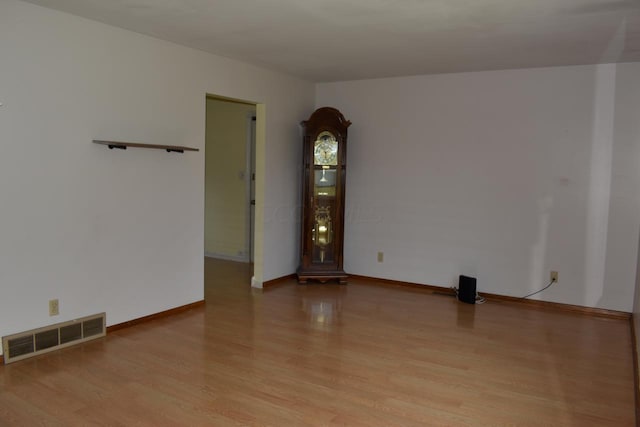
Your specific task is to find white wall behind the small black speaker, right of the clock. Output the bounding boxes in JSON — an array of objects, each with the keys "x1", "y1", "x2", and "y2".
[{"x1": 316, "y1": 63, "x2": 640, "y2": 311}]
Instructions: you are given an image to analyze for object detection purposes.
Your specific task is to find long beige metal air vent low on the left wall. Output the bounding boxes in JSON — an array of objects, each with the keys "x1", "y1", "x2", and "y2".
[{"x1": 2, "y1": 313, "x2": 106, "y2": 364}]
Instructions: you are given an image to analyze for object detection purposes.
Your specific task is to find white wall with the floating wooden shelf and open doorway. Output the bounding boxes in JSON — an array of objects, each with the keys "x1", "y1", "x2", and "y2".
[{"x1": 0, "y1": 0, "x2": 314, "y2": 354}]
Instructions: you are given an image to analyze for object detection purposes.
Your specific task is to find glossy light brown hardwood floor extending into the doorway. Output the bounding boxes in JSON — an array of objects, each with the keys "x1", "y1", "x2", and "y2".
[{"x1": 0, "y1": 259, "x2": 635, "y2": 426}]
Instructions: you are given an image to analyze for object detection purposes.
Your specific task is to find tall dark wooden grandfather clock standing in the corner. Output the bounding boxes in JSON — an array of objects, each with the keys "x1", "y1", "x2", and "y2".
[{"x1": 297, "y1": 107, "x2": 351, "y2": 284}]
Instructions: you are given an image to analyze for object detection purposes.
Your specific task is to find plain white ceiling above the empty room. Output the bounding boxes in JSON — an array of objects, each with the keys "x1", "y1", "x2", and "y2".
[{"x1": 22, "y1": 0, "x2": 640, "y2": 82}]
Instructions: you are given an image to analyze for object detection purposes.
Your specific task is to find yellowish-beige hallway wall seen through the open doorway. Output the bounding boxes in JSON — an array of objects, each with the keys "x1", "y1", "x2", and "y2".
[{"x1": 204, "y1": 98, "x2": 256, "y2": 261}]
